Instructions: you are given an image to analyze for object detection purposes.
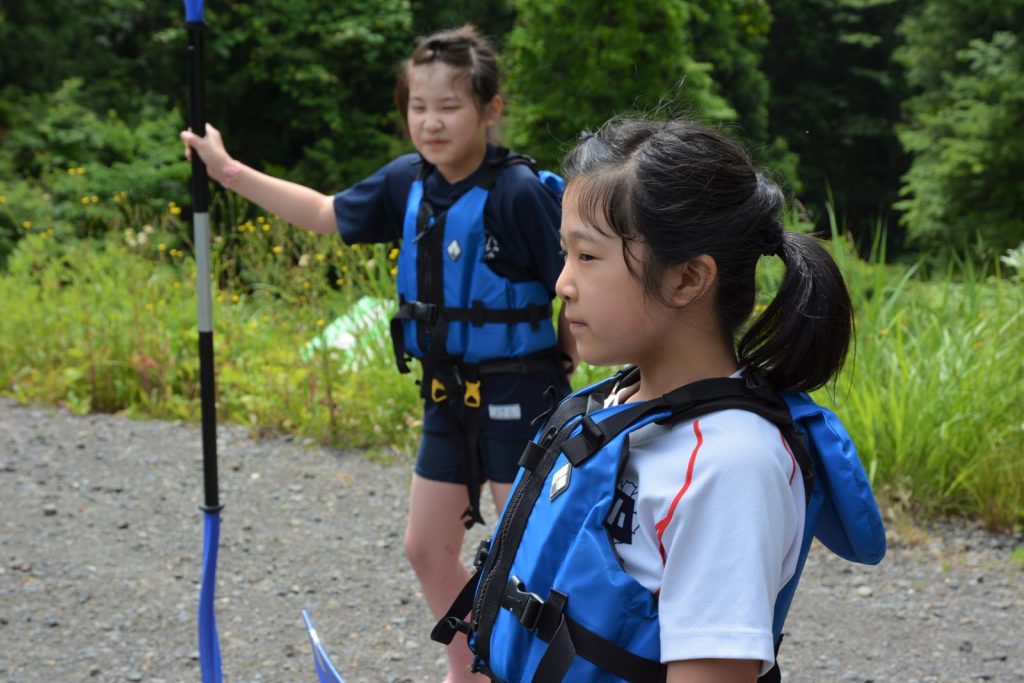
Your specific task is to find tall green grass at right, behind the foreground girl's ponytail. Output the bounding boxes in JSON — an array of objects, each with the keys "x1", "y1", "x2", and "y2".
[{"x1": 798, "y1": 219, "x2": 1024, "y2": 527}]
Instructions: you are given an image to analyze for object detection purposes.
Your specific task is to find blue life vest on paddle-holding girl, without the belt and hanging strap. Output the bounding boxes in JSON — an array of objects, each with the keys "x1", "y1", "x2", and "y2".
[{"x1": 396, "y1": 148, "x2": 561, "y2": 368}]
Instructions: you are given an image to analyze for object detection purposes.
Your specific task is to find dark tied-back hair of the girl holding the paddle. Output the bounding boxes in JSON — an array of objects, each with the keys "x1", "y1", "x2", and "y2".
[{"x1": 394, "y1": 24, "x2": 502, "y2": 124}]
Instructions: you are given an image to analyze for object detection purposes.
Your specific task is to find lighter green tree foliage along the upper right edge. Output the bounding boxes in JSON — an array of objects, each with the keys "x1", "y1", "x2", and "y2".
[{"x1": 897, "y1": 0, "x2": 1024, "y2": 252}]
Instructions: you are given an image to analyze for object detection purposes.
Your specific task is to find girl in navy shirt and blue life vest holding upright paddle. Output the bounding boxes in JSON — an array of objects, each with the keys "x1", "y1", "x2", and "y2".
[{"x1": 181, "y1": 26, "x2": 575, "y2": 682}]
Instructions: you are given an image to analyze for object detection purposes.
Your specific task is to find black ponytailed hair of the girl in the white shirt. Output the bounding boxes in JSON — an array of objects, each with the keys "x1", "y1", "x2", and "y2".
[{"x1": 564, "y1": 118, "x2": 853, "y2": 391}]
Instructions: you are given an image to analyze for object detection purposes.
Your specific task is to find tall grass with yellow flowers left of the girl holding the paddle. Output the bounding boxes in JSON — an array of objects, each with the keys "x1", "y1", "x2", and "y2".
[{"x1": 0, "y1": 204, "x2": 420, "y2": 453}]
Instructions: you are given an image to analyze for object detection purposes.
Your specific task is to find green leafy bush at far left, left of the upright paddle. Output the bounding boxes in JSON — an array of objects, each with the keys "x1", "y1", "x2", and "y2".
[{"x1": 0, "y1": 80, "x2": 188, "y2": 263}]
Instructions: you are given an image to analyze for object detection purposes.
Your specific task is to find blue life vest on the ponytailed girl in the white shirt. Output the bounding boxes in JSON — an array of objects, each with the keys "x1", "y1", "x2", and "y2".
[{"x1": 432, "y1": 369, "x2": 886, "y2": 683}]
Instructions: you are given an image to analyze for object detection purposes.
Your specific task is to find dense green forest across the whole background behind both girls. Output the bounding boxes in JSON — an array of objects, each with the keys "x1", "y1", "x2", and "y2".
[{"x1": 0, "y1": 0, "x2": 1024, "y2": 257}]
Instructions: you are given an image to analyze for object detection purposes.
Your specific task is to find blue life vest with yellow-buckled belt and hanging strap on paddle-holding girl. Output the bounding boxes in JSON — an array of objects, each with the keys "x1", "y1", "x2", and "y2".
[{"x1": 391, "y1": 147, "x2": 564, "y2": 527}]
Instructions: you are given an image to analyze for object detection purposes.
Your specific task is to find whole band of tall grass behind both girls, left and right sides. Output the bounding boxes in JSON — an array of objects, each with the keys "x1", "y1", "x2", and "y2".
[{"x1": 0, "y1": 200, "x2": 1024, "y2": 527}]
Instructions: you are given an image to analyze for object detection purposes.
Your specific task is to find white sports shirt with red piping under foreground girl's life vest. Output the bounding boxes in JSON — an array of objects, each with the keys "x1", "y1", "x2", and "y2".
[{"x1": 607, "y1": 382, "x2": 806, "y2": 673}]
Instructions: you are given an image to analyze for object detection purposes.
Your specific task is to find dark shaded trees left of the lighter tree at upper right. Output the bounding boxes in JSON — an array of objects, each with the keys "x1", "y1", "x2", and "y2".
[{"x1": 764, "y1": 0, "x2": 907, "y2": 244}]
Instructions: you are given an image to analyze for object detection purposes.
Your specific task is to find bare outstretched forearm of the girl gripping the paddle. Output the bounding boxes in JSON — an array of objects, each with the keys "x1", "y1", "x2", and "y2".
[{"x1": 220, "y1": 160, "x2": 337, "y2": 233}]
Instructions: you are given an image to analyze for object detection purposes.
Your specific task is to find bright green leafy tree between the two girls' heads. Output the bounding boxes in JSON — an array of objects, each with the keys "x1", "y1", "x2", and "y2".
[{"x1": 499, "y1": 0, "x2": 736, "y2": 168}]
